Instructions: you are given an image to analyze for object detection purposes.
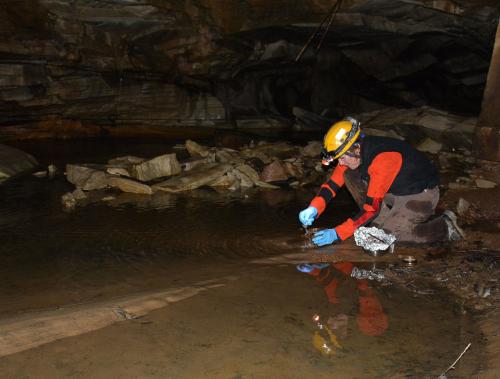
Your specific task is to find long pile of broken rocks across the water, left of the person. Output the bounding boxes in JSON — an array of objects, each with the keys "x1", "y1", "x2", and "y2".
[{"x1": 62, "y1": 140, "x2": 324, "y2": 208}]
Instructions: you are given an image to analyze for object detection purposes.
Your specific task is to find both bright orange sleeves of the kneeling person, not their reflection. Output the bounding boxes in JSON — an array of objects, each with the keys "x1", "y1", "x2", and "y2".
[{"x1": 310, "y1": 152, "x2": 403, "y2": 240}]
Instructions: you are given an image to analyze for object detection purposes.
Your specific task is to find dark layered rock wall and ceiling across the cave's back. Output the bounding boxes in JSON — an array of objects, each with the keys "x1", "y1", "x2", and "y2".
[{"x1": 0, "y1": 0, "x2": 499, "y2": 138}]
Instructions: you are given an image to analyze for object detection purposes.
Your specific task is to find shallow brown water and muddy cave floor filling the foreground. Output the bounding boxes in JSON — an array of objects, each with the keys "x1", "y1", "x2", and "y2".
[{"x1": 0, "y1": 140, "x2": 499, "y2": 378}]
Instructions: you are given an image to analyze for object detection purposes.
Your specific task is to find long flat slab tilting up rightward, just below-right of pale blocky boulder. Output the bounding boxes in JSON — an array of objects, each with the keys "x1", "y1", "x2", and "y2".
[{"x1": 153, "y1": 163, "x2": 232, "y2": 192}]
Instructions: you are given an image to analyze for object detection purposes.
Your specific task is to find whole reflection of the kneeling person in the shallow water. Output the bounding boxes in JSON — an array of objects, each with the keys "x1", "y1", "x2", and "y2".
[{"x1": 298, "y1": 262, "x2": 389, "y2": 355}]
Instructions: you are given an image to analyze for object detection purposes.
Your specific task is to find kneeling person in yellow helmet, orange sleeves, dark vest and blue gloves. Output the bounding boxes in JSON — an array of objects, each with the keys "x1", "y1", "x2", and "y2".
[{"x1": 299, "y1": 117, "x2": 463, "y2": 246}]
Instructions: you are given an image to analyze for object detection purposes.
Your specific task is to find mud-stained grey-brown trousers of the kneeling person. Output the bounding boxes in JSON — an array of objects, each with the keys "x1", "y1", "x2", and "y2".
[{"x1": 344, "y1": 170, "x2": 448, "y2": 243}]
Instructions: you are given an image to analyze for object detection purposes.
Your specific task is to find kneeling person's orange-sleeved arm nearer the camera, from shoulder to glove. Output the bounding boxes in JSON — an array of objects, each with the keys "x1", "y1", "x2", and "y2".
[{"x1": 335, "y1": 152, "x2": 403, "y2": 240}]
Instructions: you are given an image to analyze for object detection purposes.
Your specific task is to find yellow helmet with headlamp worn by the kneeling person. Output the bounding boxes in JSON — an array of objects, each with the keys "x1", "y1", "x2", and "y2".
[{"x1": 323, "y1": 117, "x2": 361, "y2": 164}]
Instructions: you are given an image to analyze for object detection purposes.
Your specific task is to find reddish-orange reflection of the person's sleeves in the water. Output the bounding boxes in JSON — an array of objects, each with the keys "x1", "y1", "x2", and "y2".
[{"x1": 309, "y1": 262, "x2": 389, "y2": 336}]
